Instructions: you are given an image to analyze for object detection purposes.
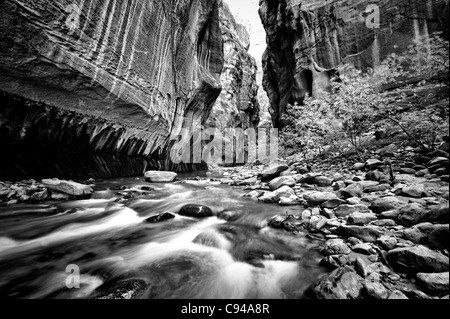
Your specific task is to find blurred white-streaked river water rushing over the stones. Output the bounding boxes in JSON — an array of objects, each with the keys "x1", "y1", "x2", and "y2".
[{"x1": 0, "y1": 173, "x2": 326, "y2": 299}]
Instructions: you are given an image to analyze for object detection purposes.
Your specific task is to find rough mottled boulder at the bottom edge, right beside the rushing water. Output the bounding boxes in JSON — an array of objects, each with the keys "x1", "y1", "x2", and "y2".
[{"x1": 305, "y1": 266, "x2": 363, "y2": 299}]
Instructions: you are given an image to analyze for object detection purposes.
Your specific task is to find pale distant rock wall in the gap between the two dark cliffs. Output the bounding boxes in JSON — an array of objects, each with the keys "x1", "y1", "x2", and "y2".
[{"x1": 207, "y1": 2, "x2": 259, "y2": 130}]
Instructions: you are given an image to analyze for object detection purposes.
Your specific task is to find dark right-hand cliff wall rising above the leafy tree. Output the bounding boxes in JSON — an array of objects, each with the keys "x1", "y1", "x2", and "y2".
[{"x1": 259, "y1": 0, "x2": 448, "y2": 125}]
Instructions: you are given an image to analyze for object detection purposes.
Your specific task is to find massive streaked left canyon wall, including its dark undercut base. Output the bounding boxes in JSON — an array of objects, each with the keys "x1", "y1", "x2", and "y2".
[{"x1": 0, "y1": 0, "x2": 223, "y2": 179}]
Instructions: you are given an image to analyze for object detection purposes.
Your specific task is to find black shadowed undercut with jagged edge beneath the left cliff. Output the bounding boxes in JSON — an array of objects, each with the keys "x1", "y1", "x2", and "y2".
[{"x1": 0, "y1": 92, "x2": 206, "y2": 181}]
